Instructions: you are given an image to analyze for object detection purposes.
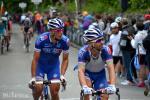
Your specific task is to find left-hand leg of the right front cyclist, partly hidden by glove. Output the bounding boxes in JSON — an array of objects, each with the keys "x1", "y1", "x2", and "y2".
[{"x1": 84, "y1": 71, "x2": 92, "y2": 100}]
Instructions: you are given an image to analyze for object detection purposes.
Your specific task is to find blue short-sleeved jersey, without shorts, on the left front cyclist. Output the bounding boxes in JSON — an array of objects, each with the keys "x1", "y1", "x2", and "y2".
[{"x1": 35, "y1": 32, "x2": 69, "y2": 68}]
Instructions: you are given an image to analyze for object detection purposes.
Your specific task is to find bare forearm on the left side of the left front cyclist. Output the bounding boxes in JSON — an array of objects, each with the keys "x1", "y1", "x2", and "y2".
[{"x1": 31, "y1": 51, "x2": 40, "y2": 77}]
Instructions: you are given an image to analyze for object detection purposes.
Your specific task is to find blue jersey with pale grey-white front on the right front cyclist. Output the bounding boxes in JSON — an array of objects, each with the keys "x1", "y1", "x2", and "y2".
[{"x1": 78, "y1": 45, "x2": 113, "y2": 72}]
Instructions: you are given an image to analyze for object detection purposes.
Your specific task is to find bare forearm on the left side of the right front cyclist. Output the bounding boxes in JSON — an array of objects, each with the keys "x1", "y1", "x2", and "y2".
[{"x1": 78, "y1": 63, "x2": 87, "y2": 86}]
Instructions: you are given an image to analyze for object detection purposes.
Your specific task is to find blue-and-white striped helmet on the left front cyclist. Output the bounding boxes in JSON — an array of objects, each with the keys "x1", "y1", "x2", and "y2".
[{"x1": 47, "y1": 18, "x2": 64, "y2": 29}]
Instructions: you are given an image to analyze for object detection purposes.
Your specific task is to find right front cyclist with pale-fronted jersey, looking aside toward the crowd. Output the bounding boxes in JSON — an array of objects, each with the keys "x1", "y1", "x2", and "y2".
[{"x1": 78, "y1": 27, "x2": 116, "y2": 100}]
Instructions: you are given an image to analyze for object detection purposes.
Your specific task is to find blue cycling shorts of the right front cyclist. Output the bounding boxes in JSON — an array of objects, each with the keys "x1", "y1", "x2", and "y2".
[{"x1": 85, "y1": 69, "x2": 108, "y2": 90}]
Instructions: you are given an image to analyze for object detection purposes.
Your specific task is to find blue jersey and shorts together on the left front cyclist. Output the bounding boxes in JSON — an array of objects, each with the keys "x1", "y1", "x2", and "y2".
[{"x1": 35, "y1": 32, "x2": 69, "y2": 80}]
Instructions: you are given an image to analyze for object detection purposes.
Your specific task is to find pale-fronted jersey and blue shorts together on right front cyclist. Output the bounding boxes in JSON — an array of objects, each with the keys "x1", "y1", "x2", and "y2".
[{"x1": 78, "y1": 45, "x2": 113, "y2": 90}]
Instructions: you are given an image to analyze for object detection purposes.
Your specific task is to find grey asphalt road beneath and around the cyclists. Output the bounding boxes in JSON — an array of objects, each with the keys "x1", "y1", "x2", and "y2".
[{"x1": 0, "y1": 24, "x2": 150, "y2": 100}]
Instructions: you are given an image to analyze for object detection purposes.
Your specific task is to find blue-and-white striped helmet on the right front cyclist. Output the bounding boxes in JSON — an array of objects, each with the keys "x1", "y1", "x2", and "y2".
[{"x1": 83, "y1": 28, "x2": 104, "y2": 43}]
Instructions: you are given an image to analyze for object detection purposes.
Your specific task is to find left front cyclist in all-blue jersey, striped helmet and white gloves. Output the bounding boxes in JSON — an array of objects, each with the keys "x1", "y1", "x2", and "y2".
[{"x1": 29, "y1": 18, "x2": 69, "y2": 100}]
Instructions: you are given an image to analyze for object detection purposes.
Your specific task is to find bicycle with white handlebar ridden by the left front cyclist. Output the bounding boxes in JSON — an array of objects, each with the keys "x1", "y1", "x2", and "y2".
[{"x1": 29, "y1": 80, "x2": 66, "y2": 100}]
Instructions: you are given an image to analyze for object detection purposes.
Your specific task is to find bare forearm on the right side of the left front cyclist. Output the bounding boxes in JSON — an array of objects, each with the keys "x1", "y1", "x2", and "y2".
[{"x1": 61, "y1": 53, "x2": 69, "y2": 75}]
